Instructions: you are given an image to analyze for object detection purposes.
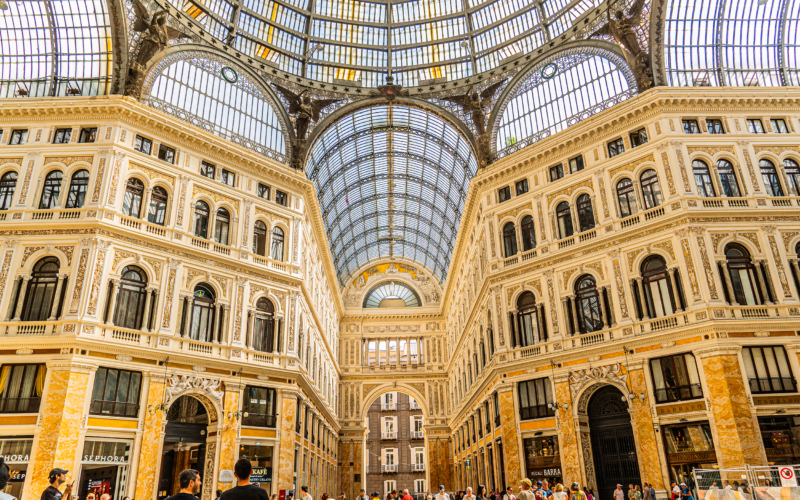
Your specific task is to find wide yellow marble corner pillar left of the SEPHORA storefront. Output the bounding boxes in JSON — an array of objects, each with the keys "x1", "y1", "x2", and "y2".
[{"x1": 30, "y1": 361, "x2": 95, "y2": 493}]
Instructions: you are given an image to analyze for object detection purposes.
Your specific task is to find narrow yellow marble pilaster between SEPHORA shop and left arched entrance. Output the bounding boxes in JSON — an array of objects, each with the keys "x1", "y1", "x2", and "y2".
[{"x1": 134, "y1": 375, "x2": 167, "y2": 500}]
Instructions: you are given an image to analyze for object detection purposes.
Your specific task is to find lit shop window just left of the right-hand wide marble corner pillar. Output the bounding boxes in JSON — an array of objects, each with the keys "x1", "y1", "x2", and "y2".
[{"x1": 661, "y1": 422, "x2": 719, "y2": 490}]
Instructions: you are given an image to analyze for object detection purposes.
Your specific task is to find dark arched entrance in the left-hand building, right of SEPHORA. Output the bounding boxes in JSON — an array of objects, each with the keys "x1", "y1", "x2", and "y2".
[{"x1": 158, "y1": 395, "x2": 213, "y2": 500}]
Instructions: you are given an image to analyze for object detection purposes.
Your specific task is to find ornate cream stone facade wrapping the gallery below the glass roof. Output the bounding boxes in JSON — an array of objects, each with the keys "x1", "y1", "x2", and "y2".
[{"x1": 0, "y1": 88, "x2": 800, "y2": 500}]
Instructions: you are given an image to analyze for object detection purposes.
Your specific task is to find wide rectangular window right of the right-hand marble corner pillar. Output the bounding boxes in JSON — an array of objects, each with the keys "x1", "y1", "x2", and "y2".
[{"x1": 742, "y1": 346, "x2": 796, "y2": 394}]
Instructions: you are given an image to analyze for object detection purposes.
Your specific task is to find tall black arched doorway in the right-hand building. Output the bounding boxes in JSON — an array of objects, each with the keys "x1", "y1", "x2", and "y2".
[{"x1": 588, "y1": 385, "x2": 641, "y2": 499}]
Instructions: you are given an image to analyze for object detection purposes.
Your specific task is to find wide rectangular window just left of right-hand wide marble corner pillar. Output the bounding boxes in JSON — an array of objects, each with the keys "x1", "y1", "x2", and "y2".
[{"x1": 650, "y1": 353, "x2": 703, "y2": 403}]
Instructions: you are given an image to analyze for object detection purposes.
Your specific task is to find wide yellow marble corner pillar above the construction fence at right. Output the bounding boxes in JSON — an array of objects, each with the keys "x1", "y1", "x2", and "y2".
[{"x1": 695, "y1": 346, "x2": 767, "y2": 469}]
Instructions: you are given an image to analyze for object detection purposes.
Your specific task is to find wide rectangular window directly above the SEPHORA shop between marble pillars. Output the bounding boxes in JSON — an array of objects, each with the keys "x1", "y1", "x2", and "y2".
[{"x1": 89, "y1": 368, "x2": 142, "y2": 417}]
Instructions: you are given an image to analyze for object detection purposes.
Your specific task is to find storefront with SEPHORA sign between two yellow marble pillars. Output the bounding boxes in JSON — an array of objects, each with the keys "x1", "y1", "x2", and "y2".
[{"x1": 75, "y1": 437, "x2": 131, "y2": 500}]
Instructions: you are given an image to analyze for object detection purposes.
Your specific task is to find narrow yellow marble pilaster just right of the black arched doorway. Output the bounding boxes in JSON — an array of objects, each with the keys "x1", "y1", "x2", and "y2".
[{"x1": 628, "y1": 370, "x2": 665, "y2": 490}]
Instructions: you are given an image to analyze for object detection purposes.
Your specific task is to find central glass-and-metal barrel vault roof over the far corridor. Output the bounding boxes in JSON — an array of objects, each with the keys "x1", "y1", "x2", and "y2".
[{"x1": 306, "y1": 105, "x2": 478, "y2": 282}]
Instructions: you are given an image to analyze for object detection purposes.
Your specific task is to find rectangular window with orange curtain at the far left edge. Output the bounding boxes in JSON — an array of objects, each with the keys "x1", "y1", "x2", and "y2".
[{"x1": 0, "y1": 365, "x2": 47, "y2": 413}]
